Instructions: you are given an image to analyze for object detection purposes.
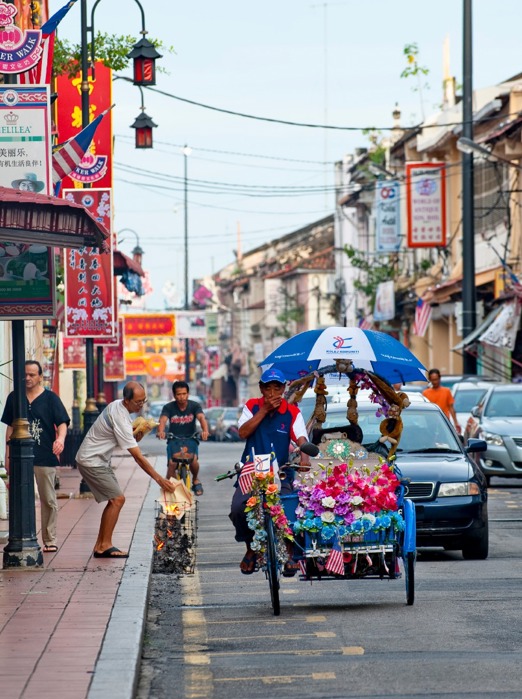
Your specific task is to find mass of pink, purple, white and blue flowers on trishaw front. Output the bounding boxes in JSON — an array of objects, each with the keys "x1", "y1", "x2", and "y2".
[{"x1": 294, "y1": 462, "x2": 404, "y2": 542}]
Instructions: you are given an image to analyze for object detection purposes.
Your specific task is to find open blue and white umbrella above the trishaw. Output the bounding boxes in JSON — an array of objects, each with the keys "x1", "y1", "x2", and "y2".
[{"x1": 259, "y1": 326, "x2": 426, "y2": 383}]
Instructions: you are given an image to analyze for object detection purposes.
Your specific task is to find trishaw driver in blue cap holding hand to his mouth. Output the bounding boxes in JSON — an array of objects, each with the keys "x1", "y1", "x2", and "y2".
[{"x1": 229, "y1": 369, "x2": 310, "y2": 576}]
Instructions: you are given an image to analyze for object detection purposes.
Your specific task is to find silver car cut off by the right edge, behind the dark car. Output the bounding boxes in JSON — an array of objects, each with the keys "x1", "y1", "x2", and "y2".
[{"x1": 464, "y1": 384, "x2": 522, "y2": 482}]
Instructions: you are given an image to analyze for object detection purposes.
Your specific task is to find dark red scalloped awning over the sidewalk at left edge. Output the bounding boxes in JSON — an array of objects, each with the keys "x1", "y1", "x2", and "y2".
[{"x1": 0, "y1": 187, "x2": 109, "y2": 252}]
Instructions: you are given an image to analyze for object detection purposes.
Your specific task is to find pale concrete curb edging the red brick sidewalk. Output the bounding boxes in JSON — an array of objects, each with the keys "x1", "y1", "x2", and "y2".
[{"x1": 87, "y1": 482, "x2": 156, "y2": 699}]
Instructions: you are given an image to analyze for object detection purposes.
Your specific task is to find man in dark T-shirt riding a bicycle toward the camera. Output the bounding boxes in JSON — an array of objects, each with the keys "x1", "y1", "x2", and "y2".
[{"x1": 157, "y1": 381, "x2": 208, "y2": 495}]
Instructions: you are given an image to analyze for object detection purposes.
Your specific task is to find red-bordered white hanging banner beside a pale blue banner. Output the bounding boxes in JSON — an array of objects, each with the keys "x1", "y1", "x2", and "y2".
[{"x1": 406, "y1": 162, "x2": 446, "y2": 248}]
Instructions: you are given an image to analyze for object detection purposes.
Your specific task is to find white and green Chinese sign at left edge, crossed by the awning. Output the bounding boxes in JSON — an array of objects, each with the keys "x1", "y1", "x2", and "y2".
[{"x1": 0, "y1": 85, "x2": 56, "y2": 320}]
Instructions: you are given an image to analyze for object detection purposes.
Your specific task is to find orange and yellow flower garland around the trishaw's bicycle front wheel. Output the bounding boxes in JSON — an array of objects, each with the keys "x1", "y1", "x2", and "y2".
[{"x1": 245, "y1": 472, "x2": 294, "y2": 565}]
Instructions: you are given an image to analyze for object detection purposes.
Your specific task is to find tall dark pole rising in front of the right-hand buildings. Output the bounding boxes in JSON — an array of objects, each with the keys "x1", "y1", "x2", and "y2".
[{"x1": 462, "y1": 0, "x2": 477, "y2": 374}]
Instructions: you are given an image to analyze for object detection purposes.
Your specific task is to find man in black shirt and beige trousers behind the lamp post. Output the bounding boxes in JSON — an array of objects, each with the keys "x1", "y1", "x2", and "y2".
[{"x1": 2, "y1": 359, "x2": 71, "y2": 553}]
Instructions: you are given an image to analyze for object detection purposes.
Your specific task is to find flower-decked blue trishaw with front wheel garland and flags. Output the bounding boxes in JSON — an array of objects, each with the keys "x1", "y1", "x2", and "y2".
[{"x1": 217, "y1": 328, "x2": 425, "y2": 616}]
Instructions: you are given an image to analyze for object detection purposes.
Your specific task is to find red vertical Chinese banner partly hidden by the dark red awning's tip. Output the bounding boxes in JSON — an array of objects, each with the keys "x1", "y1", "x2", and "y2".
[{"x1": 63, "y1": 189, "x2": 115, "y2": 338}]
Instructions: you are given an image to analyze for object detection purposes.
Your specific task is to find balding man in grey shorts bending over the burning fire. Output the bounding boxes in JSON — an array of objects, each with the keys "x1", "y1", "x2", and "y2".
[{"x1": 76, "y1": 381, "x2": 174, "y2": 558}]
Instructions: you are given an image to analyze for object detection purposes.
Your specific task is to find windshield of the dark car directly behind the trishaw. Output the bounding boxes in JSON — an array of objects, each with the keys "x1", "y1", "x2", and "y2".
[{"x1": 316, "y1": 405, "x2": 462, "y2": 454}]
